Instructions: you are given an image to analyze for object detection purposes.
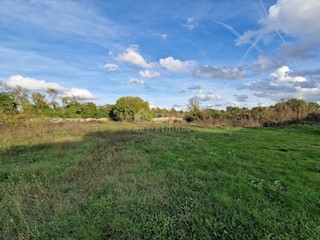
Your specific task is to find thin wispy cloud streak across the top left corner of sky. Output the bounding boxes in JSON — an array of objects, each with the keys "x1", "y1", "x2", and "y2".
[{"x1": 0, "y1": 0, "x2": 124, "y2": 44}]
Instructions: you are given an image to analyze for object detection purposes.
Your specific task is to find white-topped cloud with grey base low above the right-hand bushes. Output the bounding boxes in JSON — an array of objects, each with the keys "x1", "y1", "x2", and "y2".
[{"x1": 243, "y1": 66, "x2": 320, "y2": 101}]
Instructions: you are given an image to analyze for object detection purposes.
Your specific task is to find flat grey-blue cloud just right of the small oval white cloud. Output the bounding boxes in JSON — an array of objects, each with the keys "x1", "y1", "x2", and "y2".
[{"x1": 193, "y1": 65, "x2": 245, "y2": 80}]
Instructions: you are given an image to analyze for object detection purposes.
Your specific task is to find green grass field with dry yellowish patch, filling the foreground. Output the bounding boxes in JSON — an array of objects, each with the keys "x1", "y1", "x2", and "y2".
[{"x1": 0, "y1": 123, "x2": 320, "y2": 239}]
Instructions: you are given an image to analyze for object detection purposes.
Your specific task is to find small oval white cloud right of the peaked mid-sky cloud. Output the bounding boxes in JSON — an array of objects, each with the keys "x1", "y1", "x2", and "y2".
[{"x1": 159, "y1": 57, "x2": 195, "y2": 72}]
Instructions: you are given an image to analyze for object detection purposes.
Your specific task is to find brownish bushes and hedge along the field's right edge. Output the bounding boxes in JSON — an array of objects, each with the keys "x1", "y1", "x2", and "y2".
[{"x1": 184, "y1": 99, "x2": 320, "y2": 126}]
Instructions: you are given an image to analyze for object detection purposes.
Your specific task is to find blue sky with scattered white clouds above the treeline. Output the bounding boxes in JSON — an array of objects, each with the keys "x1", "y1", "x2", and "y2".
[{"x1": 0, "y1": 0, "x2": 320, "y2": 109}]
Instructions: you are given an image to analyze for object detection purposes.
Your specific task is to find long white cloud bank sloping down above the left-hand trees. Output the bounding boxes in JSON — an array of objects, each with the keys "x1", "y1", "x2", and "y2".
[{"x1": 5, "y1": 75, "x2": 97, "y2": 100}]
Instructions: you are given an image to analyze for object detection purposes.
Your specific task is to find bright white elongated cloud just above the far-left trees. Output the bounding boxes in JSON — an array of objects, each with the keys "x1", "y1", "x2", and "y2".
[{"x1": 6, "y1": 75, "x2": 65, "y2": 91}]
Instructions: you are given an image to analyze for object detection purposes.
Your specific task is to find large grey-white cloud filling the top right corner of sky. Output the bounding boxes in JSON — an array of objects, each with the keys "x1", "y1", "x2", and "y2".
[{"x1": 236, "y1": 0, "x2": 320, "y2": 62}]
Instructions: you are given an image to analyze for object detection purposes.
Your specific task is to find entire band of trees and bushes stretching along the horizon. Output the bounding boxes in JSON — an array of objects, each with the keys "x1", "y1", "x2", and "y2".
[{"x1": 0, "y1": 84, "x2": 320, "y2": 127}]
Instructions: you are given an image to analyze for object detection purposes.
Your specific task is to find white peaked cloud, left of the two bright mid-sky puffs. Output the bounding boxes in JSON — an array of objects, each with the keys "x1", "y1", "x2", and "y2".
[{"x1": 118, "y1": 45, "x2": 153, "y2": 68}]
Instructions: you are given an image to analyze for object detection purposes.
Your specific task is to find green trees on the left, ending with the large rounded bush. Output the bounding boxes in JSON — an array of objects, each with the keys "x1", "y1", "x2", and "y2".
[{"x1": 0, "y1": 84, "x2": 152, "y2": 121}]
